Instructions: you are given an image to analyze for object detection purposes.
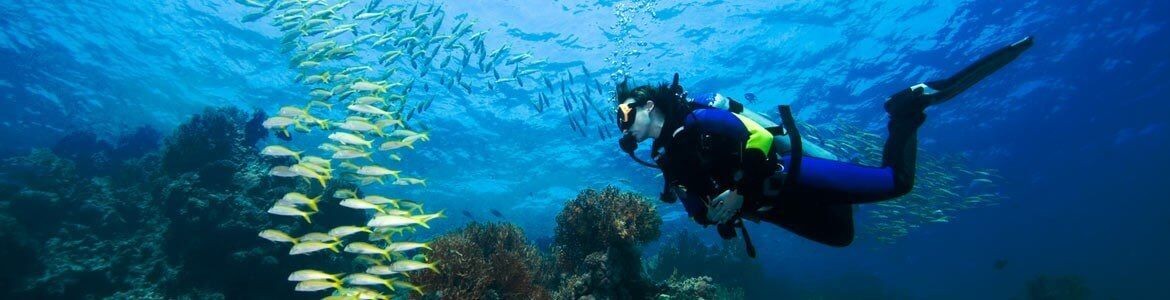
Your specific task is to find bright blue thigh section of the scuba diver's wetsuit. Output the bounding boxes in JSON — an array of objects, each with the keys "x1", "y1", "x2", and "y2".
[{"x1": 784, "y1": 156, "x2": 899, "y2": 204}]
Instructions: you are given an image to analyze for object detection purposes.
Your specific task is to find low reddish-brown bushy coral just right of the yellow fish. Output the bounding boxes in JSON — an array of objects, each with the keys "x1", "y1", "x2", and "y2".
[{"x1": 413, "y1": 223, "x2": 550, "y2": 299}]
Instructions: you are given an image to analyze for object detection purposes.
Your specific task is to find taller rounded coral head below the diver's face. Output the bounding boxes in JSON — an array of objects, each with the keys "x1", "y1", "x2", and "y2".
[{"x1": 553, "y1": 186, "x2": 662, "y2": 299}]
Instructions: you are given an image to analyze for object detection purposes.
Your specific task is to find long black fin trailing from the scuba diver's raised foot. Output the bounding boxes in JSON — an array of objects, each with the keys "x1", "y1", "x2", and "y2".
[{"x1": 910, "y1": 36, "x2": 1033, "y2": 105}]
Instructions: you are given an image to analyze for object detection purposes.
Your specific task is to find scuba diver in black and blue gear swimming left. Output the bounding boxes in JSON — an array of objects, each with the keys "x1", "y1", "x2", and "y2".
[{"x1": 615, "y1": 36, "x2": 1033, "y2": 251}]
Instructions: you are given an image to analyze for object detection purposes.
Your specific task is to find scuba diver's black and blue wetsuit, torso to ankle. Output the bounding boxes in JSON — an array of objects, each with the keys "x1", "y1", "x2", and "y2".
[{"x1": 655, "y1": 90, "x2": 928, "y2": 246}]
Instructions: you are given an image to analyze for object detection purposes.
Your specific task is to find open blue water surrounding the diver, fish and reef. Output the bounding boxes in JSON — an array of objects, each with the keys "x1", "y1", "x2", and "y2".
[{"x1": 0, "y1": 0, "x2": 1170, "y2": 299}]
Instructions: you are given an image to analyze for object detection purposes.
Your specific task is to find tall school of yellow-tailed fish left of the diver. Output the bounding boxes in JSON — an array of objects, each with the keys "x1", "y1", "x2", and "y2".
[{"x1": 236, "y1": 0, "x2": 507, "y2": 299}]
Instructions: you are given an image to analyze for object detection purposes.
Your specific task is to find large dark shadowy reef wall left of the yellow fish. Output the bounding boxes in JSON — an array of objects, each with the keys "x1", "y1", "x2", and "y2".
[{"x1": 0, "y1": 108, "x2": 325, "y2": 299}]
